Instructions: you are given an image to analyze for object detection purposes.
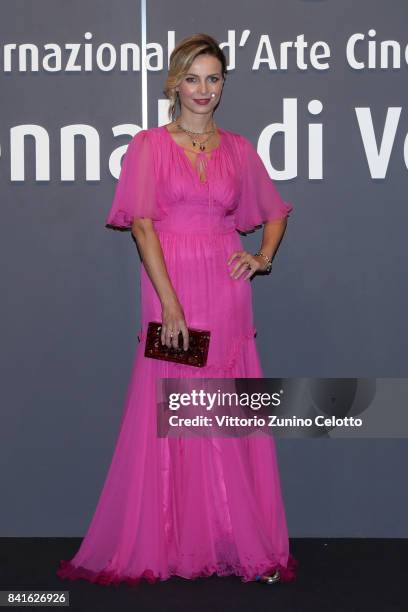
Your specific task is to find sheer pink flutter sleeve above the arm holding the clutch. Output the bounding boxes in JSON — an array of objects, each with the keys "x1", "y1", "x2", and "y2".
[{"x1": 105, "y1": 130, "x2": 162, "y2": 229}]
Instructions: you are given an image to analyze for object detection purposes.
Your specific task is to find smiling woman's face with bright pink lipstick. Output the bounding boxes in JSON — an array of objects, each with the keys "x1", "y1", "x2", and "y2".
[{"x1": 177, "y1": 54, "x2": 224, "y2": 115}]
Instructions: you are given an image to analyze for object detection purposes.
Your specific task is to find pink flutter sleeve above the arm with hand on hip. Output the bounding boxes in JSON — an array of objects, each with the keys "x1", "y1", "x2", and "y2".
[{"x1": 235, "y1": 137, "x2": 293, "y2": 232}]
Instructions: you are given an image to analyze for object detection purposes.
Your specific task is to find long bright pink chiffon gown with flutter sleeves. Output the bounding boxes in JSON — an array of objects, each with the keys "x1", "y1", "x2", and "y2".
[{"x1": 57, "y1": 126, "x2": 298, "y2": 584}]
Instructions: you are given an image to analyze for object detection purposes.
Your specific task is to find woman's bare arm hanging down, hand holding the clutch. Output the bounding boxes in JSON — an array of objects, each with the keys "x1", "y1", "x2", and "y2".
[{"x1": 132, "y1": 218, "x2": 188, "y2": 350}]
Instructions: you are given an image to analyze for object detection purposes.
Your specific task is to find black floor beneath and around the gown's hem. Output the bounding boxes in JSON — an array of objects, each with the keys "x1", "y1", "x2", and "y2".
[{"x1": 0, "y1": 538, "x2": 408, "y2": 612}]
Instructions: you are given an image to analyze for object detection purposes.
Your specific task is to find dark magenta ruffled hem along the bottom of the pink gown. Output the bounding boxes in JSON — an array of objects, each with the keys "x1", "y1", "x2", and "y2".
[{"x1": 56, "y1": 555, "x2": 299, "y2": 586}]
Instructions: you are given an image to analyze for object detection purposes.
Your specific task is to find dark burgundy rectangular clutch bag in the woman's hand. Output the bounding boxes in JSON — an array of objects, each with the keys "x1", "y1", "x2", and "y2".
[{"x1": 144, "y1": 321, "x2": 211, "y2": 368}]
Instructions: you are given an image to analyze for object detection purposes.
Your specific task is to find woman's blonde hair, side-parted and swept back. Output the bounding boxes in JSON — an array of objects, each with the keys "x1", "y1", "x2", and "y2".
[{"x1": 163, "y1": 33, "x2": 227, "y2": 121}]
